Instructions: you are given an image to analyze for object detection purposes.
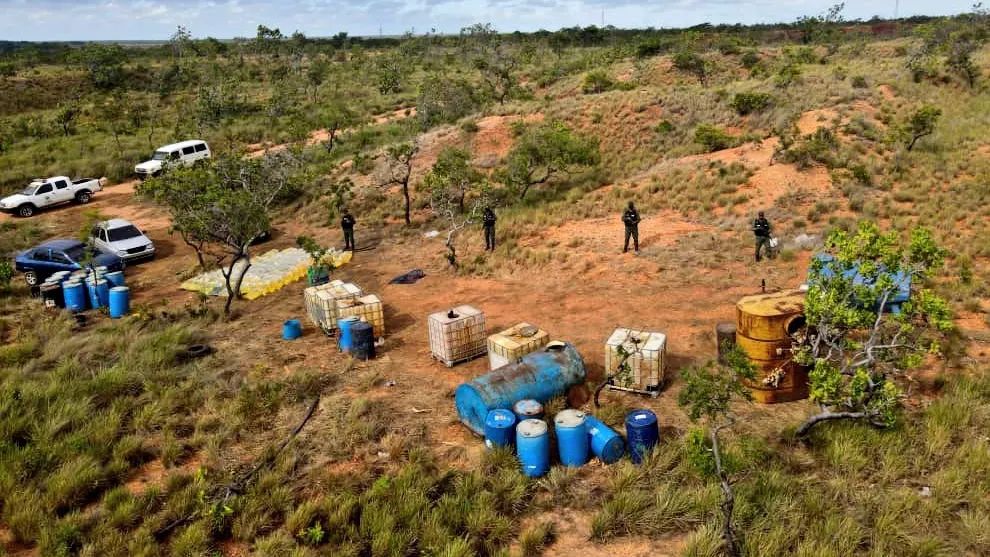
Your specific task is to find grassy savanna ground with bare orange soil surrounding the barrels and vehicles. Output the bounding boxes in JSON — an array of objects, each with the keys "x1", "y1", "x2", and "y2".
[{"x1": 0, "y1": 13, "x2": 990, "y2": 557}]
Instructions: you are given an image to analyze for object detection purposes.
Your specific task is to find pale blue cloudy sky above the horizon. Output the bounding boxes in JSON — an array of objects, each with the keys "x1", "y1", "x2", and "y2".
[{"x1": 0, "y1": 0, "x2": 974, "y2": 41}]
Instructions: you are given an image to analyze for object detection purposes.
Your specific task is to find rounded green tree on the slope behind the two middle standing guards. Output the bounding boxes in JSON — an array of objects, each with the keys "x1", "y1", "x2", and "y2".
[{"x1": 497, "y1": 121, "x2": 601, "y2": 200}]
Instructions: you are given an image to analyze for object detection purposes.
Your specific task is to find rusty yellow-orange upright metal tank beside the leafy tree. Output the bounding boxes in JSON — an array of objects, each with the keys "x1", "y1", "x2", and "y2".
[{"x1": 736, "y1": 290, "x2": 808, "y2": 404}]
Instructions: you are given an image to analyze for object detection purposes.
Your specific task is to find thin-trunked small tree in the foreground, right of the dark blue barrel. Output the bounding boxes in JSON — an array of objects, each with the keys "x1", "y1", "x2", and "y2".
[{"x1": 677, "y1": 348, "x2": 756, "y2": 556}]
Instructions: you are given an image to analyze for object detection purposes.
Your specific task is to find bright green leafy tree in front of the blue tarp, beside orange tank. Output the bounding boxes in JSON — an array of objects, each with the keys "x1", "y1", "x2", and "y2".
[{"x1": 794, "y1": 221, "x2": 953, "y2": 437}]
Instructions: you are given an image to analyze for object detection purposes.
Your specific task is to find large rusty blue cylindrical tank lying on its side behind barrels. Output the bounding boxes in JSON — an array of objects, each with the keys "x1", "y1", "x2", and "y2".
[{"x1": 454, "y1": 342, "x2": 586, "y2": 435}]
